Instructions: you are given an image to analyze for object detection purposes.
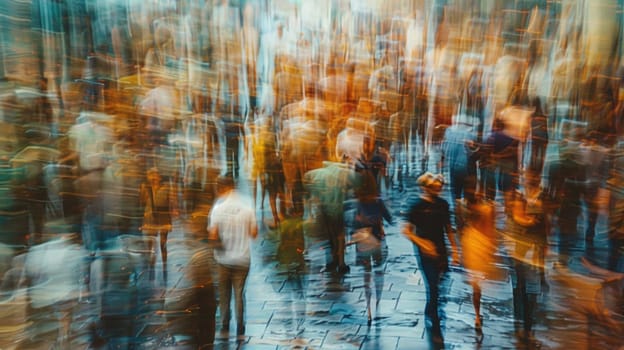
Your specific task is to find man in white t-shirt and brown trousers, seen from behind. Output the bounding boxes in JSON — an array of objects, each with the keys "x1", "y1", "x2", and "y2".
[{"x1": 208, "y1": 176, "x2": 258, "y2": 336}]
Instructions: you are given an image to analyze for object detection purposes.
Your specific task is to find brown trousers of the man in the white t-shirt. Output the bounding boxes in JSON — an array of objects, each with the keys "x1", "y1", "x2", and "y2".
[{"x1": 218, "y1": 264, "x2": 249, "y2": 333}]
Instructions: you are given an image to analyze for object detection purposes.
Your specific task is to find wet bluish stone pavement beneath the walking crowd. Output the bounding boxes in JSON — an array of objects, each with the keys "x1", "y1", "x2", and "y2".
[{"x1": 0, "y1": 167, "x2": 622, "y2": 349}]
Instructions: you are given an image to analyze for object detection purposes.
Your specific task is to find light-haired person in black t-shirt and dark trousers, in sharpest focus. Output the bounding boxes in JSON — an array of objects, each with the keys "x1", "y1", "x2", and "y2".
[{"x1": 403, "y1": 173, "x2": 459, "y2": 344}]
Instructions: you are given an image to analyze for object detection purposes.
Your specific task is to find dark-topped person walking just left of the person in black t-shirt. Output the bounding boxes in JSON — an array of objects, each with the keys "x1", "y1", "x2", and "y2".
[{"x1": 352, "y1": 174, "x2": 392, "y2": 325}]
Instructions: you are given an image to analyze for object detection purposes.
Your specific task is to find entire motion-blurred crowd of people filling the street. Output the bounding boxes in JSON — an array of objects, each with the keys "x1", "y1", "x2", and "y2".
[{"x1": 0, "y1": 0, "x2": 624, "y2": 344}]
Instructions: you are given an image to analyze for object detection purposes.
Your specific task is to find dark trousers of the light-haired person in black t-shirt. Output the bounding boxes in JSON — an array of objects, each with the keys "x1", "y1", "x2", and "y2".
[{"x1": 417, "y1": 254, "x2": 448, "y2": 336}]
